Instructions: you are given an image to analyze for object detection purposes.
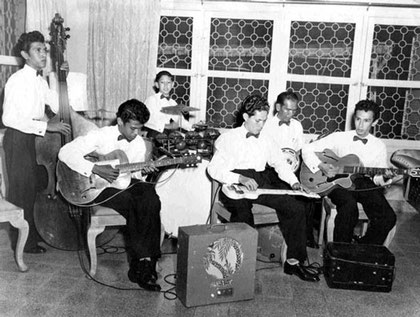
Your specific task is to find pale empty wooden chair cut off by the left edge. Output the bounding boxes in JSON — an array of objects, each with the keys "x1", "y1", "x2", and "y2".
[{"x1": 0, "y1": 199, "x2": 29, "y2": 272}]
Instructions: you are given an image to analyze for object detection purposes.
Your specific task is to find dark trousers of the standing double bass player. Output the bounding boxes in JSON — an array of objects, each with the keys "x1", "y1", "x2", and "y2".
[{"x1": 3, "y1": 128, "x2": 42, "y2": 250}]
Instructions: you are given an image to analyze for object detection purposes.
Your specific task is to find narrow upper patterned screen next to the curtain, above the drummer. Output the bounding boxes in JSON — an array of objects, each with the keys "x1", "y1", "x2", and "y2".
[{"x1": 157, "y1": 16, "x2": 193, "y2": 69}]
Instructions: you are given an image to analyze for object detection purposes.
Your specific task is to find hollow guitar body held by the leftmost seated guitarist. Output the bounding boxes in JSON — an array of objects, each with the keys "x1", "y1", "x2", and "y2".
[{"x1": 57, "y1": 150, "x2": 131, "y2": 205}]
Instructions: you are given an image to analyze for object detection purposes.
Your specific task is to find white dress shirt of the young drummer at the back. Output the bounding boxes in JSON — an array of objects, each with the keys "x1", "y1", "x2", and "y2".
[{"x1": 144, "y1": 92, "x2": 192, "y2": 132}]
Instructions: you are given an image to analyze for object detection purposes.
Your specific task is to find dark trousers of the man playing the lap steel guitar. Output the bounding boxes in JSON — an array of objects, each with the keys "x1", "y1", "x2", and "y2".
[{"x1": 220, "y1": 170, "x2": 307, "y2": 262}]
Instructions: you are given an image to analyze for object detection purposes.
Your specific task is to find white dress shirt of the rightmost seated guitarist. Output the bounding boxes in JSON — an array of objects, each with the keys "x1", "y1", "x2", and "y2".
[{"x1": 302, "y1": 130, "x2": 389, "y2": 173}]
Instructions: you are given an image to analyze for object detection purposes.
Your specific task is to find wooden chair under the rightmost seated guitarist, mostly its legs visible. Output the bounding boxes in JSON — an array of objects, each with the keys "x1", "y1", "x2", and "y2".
[{"x1": 318, "y1": 197, "x2": 396, "y2": 247}]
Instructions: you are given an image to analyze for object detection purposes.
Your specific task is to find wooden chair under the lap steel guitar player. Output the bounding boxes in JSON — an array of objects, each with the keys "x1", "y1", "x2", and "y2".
[{"x1": 210, "y1": 180, "x2": 287, "y2": 263}]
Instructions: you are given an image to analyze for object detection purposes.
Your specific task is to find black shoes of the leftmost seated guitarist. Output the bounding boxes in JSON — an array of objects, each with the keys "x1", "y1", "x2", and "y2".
[{"x1": 128, "y1": 260, "x2": 161, "y2": 292}]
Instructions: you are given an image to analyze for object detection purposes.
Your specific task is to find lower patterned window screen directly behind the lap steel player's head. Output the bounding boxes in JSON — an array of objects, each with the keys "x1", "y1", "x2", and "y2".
[{"x1": 206, "y1": 77, "x2": 268, "y2": 128}]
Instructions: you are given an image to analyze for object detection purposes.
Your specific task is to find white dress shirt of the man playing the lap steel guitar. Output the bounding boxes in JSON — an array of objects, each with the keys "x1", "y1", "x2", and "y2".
[{"x1": 207, "y1": 125, "x2": 299, "y2": 185}]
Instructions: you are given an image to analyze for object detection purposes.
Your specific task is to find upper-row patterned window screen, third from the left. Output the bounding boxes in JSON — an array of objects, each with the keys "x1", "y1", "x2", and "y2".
[{"x1": 288, "y1": 21, "x2": 355, "y2": 77}]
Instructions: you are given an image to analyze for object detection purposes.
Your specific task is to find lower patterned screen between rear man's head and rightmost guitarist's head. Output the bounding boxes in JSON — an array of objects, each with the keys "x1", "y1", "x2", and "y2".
[{"x1": 287, "y1": 82, "x2": 349, "y2": 134}]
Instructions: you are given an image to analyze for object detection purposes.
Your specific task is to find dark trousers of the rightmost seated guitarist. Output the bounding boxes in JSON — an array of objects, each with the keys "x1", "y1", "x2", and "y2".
[{"x1": 328, "y1": 177, "x2": 396, "y2": 244}]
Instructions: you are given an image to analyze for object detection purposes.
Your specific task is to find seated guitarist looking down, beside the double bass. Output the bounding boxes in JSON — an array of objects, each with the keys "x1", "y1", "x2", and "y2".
[{"x1": 59, "y1": 99, "x2": 161, "y2": 291}]
